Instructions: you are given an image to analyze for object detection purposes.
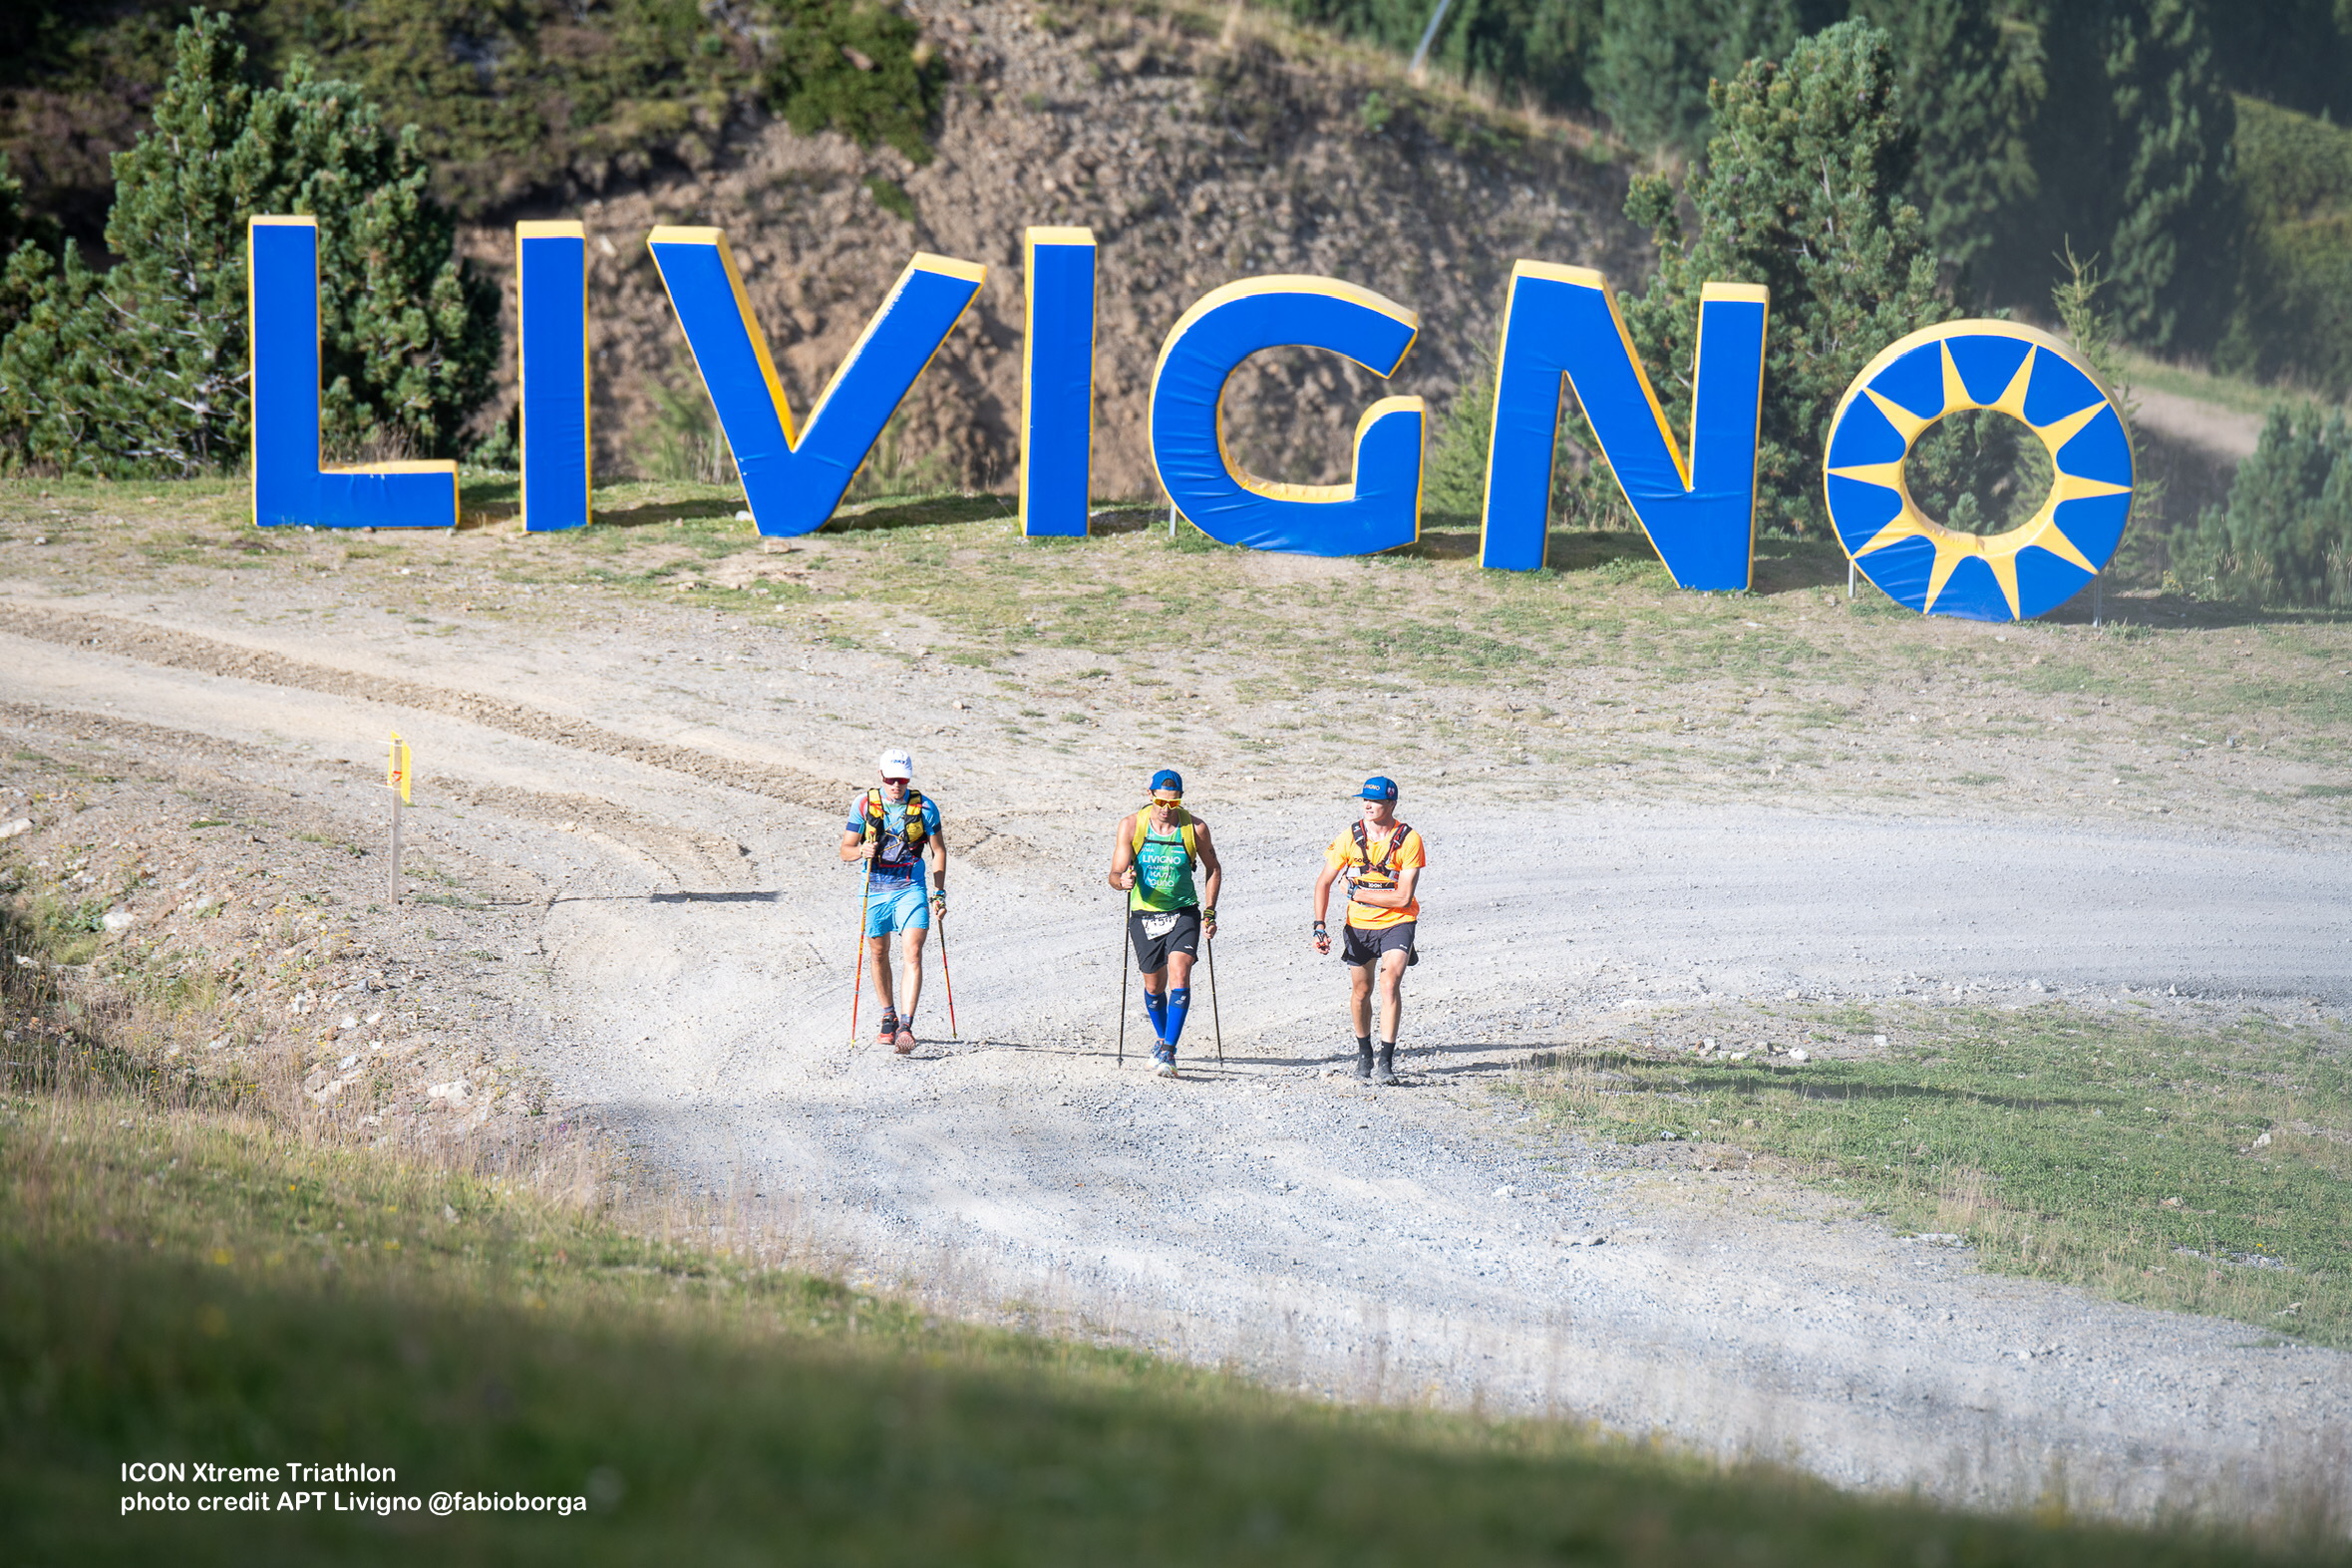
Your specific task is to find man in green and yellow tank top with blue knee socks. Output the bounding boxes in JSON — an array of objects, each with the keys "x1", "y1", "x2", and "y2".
[{"x1": 1110, "y1": 769, "x2": 1225, "y2": 1079}]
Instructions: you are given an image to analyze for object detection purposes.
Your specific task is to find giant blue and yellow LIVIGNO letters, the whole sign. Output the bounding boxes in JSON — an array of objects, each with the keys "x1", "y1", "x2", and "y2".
[{"x1": 249, "y1": 216, "x2": 2134, "y2": 621}]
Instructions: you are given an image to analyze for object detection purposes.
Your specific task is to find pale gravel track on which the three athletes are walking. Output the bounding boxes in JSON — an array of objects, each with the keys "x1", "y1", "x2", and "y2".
[{"x1": 0, "y1": 571, "x2": 2352, "y2": 1511}]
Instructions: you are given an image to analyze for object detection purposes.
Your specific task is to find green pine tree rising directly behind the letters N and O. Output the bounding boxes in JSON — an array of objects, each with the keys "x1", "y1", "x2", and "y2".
[{"x1": 1620, "y1": 21, "x2": 1954, "y2": 529}]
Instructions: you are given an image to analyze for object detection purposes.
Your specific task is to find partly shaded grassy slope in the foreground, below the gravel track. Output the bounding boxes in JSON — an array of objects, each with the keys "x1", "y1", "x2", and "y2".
[{"x1": 0, "y1": 1094, "x2": 2333, "y2": 1568}]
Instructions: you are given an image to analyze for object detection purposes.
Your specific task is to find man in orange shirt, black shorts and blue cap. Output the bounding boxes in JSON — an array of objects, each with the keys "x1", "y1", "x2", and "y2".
[{"x1": 1312, "y1": 779, "x2": 1428, "y2": 1084}]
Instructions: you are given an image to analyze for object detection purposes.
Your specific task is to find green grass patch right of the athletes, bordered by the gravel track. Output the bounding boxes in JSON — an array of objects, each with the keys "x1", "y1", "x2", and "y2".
[{"x1": 1519, "y1": 1004, "x2": 2352, "y2": 1347}]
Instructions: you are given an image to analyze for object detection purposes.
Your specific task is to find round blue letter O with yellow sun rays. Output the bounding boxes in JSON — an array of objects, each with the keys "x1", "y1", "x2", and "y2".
[{"x1": 1821, "y1": 322, "x2": 2131, "y2": 621}]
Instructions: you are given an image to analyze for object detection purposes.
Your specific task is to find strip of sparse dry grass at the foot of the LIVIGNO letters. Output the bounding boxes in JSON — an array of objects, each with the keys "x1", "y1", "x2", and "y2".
[{"x1": 23, "y1": 470, "x2": 2352, "y2": 808}]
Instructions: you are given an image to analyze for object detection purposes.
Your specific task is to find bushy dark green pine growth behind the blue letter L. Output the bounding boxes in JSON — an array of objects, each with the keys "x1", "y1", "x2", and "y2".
[{"x1": 0, "y1": 12, "x2": 499, "y2": 474}]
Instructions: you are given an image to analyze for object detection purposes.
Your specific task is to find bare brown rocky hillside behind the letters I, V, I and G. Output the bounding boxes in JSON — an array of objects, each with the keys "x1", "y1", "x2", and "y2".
[{"x1": 454, "y1": 2, "x2": 1646, "y2": 496}]
